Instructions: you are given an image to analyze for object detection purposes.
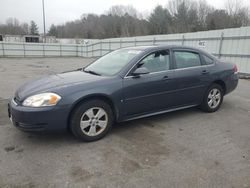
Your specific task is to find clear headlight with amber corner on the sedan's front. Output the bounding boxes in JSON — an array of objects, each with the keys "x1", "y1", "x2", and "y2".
[{"x1": 23, "y1": 93, "x2": 61, "y2": 107}]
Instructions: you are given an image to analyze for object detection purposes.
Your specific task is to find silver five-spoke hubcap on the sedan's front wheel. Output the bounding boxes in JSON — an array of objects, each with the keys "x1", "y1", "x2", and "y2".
[{"x1": 80, "y1": 107, "x2": 108, "y2": 136}]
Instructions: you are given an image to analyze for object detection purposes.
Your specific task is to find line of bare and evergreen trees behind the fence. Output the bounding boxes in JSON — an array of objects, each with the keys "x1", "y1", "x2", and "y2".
[{"x1": 0, "y1": 0, "x2": 250, "y2": 39}]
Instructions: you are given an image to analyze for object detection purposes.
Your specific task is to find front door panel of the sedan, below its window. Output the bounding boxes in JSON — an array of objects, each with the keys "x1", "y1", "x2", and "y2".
[{"x1": 123, "y1": 70, "x2": 174, "y2": 116}]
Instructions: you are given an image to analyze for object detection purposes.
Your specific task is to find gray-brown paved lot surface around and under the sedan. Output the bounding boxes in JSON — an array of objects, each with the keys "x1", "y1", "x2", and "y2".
[{"x1": 0, "y1": 58, "x2": 250, "y2": 188}]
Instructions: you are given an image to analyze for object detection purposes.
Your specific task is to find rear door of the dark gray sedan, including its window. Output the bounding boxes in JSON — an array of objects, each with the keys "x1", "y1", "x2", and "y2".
[{"x1": 173, "y1": 50, "x2": 209, "y2": 106}]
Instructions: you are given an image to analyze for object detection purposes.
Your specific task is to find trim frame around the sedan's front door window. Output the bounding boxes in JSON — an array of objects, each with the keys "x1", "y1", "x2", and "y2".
[{"x1": 123, "y1": 48, "x2": 174, "y2": 78}]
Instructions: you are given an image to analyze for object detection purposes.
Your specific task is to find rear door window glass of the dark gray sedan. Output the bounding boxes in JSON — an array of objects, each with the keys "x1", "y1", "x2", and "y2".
[{"x1": 174, "y1": 51, "x2": 201, "y2": 69}]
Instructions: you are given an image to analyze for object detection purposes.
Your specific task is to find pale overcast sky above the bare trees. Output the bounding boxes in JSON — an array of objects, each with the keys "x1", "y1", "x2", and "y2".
[{"x1": 0, "y1": 0, "x2": 250, "y2": 31}]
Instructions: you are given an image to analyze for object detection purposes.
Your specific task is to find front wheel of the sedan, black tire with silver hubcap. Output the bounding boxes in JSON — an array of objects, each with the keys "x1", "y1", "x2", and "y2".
[{"x1": 70, "y1": 100, "x2": 114, "y2": 142}]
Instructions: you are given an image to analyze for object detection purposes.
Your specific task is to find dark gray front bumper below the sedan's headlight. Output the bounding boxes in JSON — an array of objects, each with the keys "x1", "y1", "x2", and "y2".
[{"x1": 8, "y1": 100, "x2": 69, "y2": 132}]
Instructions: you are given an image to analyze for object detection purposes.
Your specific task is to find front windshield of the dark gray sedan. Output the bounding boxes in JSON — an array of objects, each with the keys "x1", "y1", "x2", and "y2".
[{"x1": 84, "y1": 49, "x2": 141, "y2": 76}]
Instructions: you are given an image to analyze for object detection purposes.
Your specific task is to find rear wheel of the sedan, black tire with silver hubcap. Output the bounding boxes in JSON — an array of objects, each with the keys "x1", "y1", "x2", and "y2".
[{"x1": 200, "y1": 84, "x2": 224, "y2": 113}]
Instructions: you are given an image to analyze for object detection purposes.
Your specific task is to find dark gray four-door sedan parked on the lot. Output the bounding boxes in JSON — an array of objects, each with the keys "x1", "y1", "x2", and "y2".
[{"x1": 8, "y1": 46, "x2": 238, "y2": 141}]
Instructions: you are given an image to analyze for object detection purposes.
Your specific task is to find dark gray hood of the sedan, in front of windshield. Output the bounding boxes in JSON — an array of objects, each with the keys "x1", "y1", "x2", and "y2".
[{"x1": 15, "y1": 71, "x2": 104, "y2": 101}]
